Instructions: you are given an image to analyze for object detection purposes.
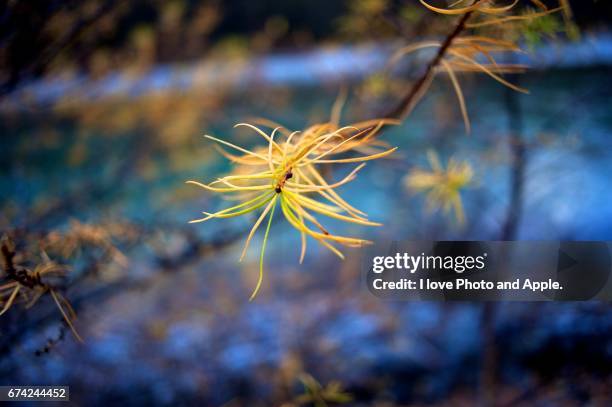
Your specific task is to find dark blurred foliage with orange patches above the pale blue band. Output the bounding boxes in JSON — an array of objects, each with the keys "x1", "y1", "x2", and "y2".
[{"x1": 0, "y1": 0, "x2": 611, "y2": 92}]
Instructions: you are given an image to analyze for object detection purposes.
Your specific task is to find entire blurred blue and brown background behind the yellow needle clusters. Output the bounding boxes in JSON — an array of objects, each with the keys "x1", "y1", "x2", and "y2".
[{"x1": 0, "y1": 0, "x2": 612, "y2": 406}]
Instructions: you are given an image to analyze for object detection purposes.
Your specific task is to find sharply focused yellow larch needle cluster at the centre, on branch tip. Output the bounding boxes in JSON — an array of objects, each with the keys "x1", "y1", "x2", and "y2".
[{"x1": 187, "y1": 119, "x2": 396, "y2": 300}]
